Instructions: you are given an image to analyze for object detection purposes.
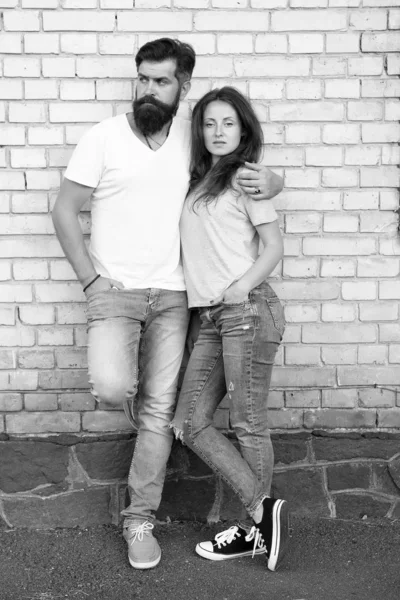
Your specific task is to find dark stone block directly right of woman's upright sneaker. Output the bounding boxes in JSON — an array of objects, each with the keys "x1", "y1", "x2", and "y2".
[{"x1": 272, "y1": 469, "x2": 329, "y2": 517}]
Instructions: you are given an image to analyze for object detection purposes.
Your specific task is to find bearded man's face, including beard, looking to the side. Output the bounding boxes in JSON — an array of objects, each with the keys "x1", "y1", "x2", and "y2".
[{"x1": 133, "y1": 60, "x2": 190, "y2": 135}]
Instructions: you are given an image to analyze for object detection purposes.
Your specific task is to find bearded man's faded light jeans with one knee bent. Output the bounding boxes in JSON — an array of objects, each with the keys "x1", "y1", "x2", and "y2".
[{"x1": 88, "y1": 289, "x2": 189, "y2": 526}]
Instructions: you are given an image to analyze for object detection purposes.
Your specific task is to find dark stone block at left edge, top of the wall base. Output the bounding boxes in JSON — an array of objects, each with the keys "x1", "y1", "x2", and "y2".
[{"x1": 0, "y1": 441, "x2": 68, "y2": 494}]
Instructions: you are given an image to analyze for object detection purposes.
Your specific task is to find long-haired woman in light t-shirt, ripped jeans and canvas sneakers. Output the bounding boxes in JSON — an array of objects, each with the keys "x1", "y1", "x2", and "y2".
[{"x1": 171, "y1": 87, "x2": 288, "y2": 571}]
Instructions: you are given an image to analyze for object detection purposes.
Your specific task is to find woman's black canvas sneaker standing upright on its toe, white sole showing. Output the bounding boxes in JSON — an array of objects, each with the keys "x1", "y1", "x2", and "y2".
[{"x1": 255, "y1": 498, "x2": 289, "y2": 571}]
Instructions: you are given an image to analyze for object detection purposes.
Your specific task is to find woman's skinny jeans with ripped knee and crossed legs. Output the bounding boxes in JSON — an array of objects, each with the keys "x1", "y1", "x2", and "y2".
[{"x1": 171, "y1": 283, "x2": 284, "y2": 515}]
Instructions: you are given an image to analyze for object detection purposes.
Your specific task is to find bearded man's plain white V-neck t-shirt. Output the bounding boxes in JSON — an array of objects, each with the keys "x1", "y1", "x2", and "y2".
[{"x1": 65, "y1": 114, "x2": 190, "y2": 290}]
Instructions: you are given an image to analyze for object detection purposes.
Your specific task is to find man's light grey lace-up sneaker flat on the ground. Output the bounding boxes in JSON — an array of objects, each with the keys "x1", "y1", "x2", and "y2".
[{"x1": 123, "y1": 521, "x2": 161, "y2": 569}]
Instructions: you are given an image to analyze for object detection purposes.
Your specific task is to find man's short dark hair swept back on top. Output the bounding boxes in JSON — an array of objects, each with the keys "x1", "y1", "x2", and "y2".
[{"x1": 135, "y1": 38, "x2": 196, "y2": 84}]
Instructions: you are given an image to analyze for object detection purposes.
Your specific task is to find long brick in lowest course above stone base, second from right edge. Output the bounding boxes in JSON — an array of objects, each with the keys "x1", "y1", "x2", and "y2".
[{"x1": 304, "y1": 410, "x2": 376, "y2": 429}]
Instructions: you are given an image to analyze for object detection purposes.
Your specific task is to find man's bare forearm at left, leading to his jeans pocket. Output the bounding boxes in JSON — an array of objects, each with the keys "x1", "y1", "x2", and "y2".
[{"x1": 52, "y1": 204, "x2": 96, "y2": 286}]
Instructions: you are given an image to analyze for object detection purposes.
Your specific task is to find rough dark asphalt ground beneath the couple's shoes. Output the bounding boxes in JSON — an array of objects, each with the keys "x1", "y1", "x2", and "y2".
[{"x1": 0, "y1": 518, "x2": 400, "y2": 600}]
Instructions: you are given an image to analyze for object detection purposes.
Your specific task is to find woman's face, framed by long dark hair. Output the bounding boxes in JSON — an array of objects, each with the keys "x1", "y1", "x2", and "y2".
[{"x1": 203, "y1": 100, "x2": 242, "y2": 165}]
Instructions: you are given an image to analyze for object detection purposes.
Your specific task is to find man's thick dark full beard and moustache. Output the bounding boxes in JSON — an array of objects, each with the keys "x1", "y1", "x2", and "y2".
[{"x1": 132, "y1": 90, "x2": 180, "y2": 135}]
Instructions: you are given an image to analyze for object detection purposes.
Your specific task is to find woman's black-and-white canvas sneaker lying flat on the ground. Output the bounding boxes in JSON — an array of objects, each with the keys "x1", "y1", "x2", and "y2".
[{"x1": 196, "y1": 525, "x2": 266, "y2": 560}]
